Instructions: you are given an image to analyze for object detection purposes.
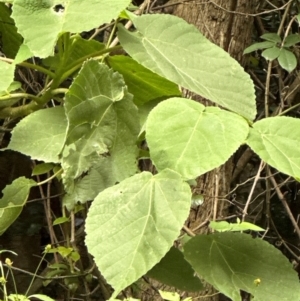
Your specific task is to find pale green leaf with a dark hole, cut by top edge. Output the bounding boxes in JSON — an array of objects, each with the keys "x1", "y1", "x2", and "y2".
[{"x1": 12, "y1": 0, "x2": 131, "y2": 58}]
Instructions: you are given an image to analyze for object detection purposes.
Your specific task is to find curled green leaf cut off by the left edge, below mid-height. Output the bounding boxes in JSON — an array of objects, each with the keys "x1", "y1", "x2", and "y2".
[{"x1": 0, "y1": 177, "x2": 36, "y2": 235}]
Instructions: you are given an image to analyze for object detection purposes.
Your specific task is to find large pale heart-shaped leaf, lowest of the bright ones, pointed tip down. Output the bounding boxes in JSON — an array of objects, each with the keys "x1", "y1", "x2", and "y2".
[{"x1": 86, "y1": 170, "x2": 191, "y2": 298}]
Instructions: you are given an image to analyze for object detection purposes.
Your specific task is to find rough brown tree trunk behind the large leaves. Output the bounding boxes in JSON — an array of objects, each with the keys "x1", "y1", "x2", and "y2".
[{"x1": 168, "y1": 0, "x2": 258, "y2": 301}]
